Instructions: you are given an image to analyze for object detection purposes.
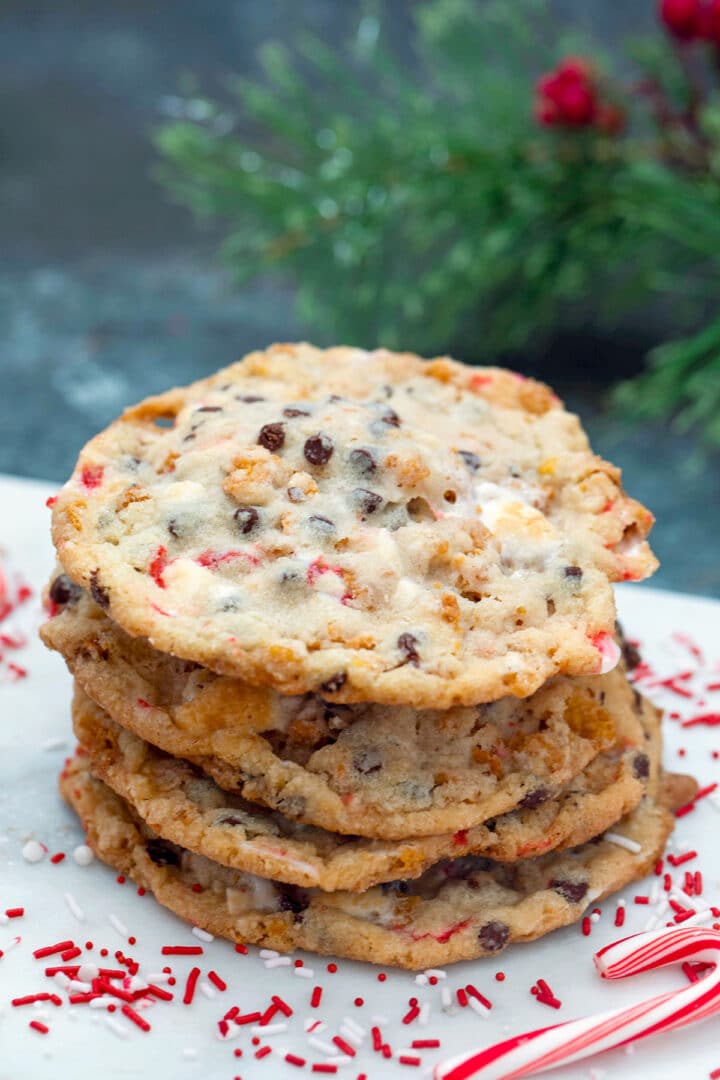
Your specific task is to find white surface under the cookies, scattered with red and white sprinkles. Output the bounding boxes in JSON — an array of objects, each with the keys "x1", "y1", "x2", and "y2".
[{"x1": 0, "y1": 478, "x2": 720, "y2": 1080}]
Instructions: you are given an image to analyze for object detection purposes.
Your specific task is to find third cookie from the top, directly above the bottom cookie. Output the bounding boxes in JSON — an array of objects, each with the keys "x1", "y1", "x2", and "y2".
[{"x1": 73, "y1": 696, "x2": 661, "y2": 891}]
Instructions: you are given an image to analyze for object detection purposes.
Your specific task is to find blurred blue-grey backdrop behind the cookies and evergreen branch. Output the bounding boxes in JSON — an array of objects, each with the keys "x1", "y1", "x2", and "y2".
[{"x1": 0, "y1": 0, "x2": 720, "y2": 596}]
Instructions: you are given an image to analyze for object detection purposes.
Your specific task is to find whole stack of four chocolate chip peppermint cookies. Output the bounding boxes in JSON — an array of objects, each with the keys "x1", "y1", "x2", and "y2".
[{"x1": 42, "y1": 345, "x2": 691, "y2": 969}]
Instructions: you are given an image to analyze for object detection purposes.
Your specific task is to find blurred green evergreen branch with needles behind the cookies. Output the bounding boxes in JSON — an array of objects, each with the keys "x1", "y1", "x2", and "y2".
[{"x1": 157, "y1": 0, "x2": 720, "y2": 444}]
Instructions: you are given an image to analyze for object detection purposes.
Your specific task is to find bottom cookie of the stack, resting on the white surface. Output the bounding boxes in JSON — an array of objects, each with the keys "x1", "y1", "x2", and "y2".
[{"x1": 60, "y1": 756, "x2": 694, "y2": 970}]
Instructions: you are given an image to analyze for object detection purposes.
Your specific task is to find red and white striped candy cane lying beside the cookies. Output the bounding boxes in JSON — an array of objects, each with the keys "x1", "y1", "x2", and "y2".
[{"x1": 434, "y1": 927, "x2": 720, "y2": 1080}]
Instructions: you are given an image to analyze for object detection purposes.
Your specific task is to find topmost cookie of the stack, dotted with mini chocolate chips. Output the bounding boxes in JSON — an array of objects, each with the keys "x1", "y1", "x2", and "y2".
[{"x1": 53, "y1": 345, "x2": 656, "y2": 708}]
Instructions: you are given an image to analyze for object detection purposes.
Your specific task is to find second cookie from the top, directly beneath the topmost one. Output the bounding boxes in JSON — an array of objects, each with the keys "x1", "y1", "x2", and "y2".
[{"x1": 42, "y1": 598, "x2": 634, "y2": 839}]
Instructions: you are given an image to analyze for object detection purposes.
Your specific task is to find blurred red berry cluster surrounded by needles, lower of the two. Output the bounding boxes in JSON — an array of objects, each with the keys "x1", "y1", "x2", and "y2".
[{"x1": 535, "y1": 57, "x2": 625, "y2": 135}]
